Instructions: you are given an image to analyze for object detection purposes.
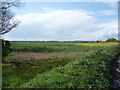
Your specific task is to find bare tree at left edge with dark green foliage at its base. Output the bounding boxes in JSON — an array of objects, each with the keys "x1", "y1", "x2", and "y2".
[{"x1": 0, "y1": 0, "x2": 22, "y2": 62}]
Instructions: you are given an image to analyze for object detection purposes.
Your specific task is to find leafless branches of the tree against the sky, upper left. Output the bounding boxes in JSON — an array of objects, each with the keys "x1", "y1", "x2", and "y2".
[{"x1": 0, "y1": 0, "x2": 22, "y2": 35}]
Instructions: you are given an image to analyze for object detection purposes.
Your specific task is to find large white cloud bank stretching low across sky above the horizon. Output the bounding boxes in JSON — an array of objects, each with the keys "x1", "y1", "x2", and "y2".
[{"x1": 4, "y1": 10, "x2": 117, "y2": 40}]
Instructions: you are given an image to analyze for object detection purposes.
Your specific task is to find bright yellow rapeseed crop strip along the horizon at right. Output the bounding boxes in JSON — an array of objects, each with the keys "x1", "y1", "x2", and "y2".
[{"x1": 75, "y1": 42, "x2": 120, "y2": 46}]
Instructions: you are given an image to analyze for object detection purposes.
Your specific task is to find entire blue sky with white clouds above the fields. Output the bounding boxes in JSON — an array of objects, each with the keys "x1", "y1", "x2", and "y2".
[{"x1": 3, "y1": 2, "x2": 118, "y2": 41}]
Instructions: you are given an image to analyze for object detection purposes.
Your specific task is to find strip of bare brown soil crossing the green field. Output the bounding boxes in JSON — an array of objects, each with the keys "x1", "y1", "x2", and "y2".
[{"x1": 12, "y1": 51, "x2": 93, "y2": 62}]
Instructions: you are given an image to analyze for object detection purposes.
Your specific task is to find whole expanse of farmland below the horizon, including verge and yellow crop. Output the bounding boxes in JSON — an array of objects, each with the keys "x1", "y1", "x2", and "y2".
[{"x1": 2, "y1": 42, "x2": 119, "y2": 88}]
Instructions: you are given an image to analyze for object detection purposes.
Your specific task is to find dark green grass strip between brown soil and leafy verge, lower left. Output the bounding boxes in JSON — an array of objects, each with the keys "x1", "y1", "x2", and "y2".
[{"x1": 2, "y1": 55, "x2": 86, "y2": 88}]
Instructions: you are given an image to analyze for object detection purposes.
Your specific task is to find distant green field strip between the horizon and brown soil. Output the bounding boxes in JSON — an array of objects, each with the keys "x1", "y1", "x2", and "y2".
[{"x1": 11, "y1": 42, "x2": 104, "y2": 53}]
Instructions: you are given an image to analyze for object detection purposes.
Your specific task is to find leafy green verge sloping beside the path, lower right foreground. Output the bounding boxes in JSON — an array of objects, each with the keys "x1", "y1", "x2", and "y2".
[{"x1": 19, "y1": 46, "x2": 118, "y2": 88}]
